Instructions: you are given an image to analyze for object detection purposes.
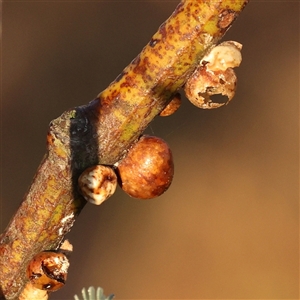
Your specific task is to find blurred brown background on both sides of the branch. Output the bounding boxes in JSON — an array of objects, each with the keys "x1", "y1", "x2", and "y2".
[{"x1": 1, "y1": 0, "x2": 300, "y2": 299}]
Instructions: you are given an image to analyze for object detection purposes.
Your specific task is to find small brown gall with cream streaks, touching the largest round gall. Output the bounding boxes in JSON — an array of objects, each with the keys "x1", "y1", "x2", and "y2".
[{"x1": 78, "y1": 165, "x2": 117, "y2": 205}]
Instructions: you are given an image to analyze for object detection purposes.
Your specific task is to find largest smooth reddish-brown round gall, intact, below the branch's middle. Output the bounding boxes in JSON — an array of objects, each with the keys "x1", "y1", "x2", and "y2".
[{"x1": 117, "y1": 136, "x2": 174, "y2": 199}]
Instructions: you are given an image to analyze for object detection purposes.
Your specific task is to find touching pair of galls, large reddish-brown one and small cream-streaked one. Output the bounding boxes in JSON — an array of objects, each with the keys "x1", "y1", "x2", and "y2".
[{"x1": 78, "y1": 135, "x2": 174, "y2": 205}]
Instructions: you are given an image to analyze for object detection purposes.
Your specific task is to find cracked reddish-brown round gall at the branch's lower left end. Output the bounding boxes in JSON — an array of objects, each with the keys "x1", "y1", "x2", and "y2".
[{"x1": 26, "y1": 251, "x2": 70, "y2": 292}]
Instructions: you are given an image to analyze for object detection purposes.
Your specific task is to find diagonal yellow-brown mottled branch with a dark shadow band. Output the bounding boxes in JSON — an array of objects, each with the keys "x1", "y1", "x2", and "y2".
[{"x1": 0, "y1": 0, "x2": 248, "y2": 299}]
